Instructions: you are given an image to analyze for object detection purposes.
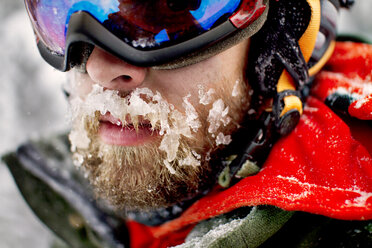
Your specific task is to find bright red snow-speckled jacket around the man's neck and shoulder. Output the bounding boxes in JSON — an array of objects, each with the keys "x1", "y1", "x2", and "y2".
[{"x1": 128, "y1": 42, "x2": 372, "y2": 247}]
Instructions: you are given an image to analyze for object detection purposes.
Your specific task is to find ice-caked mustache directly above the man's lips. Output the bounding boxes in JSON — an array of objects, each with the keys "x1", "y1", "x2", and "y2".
[{"x1": 70, "y1": 85, "x2": 200, "y2": 136}]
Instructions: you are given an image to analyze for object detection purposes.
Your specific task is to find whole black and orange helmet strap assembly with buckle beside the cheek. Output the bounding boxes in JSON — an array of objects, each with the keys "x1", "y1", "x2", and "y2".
[{"x1": 219, "y1": 0, "x2": 354, "y2": 187}]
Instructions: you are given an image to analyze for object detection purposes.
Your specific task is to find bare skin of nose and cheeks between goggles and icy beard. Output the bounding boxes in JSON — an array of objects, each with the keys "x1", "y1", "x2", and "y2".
[{"x1": 77, "y1": 40, "x2": 248, "y2": 106}]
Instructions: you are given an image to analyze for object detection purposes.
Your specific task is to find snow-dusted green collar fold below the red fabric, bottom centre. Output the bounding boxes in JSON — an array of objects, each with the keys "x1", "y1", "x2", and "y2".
[{"x1": 178, "y1": 206, "x2": 293, "y2": 248}]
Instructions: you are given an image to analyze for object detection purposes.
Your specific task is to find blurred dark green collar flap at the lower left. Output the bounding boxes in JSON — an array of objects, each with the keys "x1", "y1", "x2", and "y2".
[{"x1": 2, "y1": 135, "x2": 128, "y2": 248}]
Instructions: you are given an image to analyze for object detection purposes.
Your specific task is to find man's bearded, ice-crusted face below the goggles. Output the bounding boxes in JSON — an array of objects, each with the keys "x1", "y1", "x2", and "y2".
[{"x1": 70, "y1": 41, "x2": 249, "y2": 209}]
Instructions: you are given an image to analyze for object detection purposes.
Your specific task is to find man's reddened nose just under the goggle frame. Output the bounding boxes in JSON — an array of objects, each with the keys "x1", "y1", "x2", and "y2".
[{"x1": 86, "y1": 47, "x2": 147, "y2": 91}]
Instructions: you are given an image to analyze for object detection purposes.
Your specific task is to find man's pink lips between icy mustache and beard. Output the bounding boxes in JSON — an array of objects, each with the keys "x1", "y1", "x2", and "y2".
[{"x1": 98, "y1": 113, "x2": 159, "y2": 146}]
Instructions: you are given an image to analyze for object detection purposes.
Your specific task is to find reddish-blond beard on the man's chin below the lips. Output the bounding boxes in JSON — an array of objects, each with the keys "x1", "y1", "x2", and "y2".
[{"x1": 81, "y1": 135, "x2": 209, "y2": 210}]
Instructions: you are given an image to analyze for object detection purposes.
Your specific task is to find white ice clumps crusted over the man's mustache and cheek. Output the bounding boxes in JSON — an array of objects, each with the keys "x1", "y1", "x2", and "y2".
[{"x1": 69, "y1": 80, "x2": 247, "y2": 174}]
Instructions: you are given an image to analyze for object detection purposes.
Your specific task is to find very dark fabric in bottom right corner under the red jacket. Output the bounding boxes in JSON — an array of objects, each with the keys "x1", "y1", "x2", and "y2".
[{"x1": 260, "y1": 212, "x2": 372, "y2": 248}]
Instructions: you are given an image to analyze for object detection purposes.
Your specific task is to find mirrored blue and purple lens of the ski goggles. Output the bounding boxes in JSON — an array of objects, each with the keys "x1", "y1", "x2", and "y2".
[{"x1": 36, "y1": 0, "x2": 241, "y2": 50}]
